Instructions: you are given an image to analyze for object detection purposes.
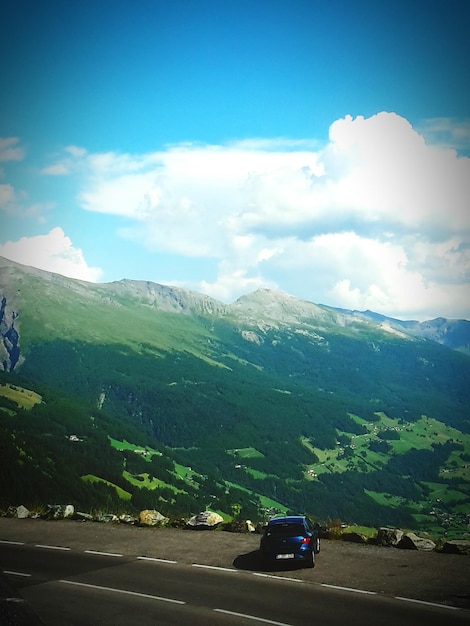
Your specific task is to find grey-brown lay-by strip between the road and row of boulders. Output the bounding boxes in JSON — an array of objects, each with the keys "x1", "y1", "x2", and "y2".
[{"x1": 0, "y1": 518, "x2": 470, "y2": 609}]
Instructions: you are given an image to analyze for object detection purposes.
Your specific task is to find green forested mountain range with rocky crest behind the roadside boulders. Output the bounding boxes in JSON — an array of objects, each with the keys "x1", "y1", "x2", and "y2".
[{"x1": 0, "y1": 259, "x2": 470, "y2": 532}]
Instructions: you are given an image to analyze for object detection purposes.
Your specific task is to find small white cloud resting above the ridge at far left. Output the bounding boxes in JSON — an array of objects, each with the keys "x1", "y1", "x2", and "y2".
[{"x1": 0, "y1": 227, "x2": 102, "y2": 282}]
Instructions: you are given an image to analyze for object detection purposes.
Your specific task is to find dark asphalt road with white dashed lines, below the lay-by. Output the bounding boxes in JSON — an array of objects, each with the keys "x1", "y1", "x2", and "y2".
[{"x1": 0, "y1": 542, "x2": 469, "y2": 626}]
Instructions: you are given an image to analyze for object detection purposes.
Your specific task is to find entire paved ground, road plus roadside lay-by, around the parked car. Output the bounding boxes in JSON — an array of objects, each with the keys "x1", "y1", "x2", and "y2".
[{"x1": 0, "y1": 518, "x2": 470, "y2": 626}]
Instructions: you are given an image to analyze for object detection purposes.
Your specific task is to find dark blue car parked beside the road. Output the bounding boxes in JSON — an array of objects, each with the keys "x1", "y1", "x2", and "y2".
[{"x1": 260, "y1": 515, "x2": 320, "y2": 567}]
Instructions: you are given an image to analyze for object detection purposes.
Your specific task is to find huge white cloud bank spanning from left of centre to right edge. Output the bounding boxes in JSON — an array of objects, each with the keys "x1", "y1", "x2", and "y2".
[{"x1": 71, "y1": 113, "x2": 470, "y2": 318}]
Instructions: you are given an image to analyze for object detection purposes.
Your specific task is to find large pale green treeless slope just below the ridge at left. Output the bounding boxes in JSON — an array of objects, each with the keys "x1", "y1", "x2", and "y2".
[{"x1": 17, "y1": 275, "x2": 226, "y2": 368}]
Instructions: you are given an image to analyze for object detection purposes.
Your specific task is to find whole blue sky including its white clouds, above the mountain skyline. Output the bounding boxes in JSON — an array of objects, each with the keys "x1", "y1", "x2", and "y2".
[{"x1": 0, "y1": 0, "x2": 470, "y2": 319}]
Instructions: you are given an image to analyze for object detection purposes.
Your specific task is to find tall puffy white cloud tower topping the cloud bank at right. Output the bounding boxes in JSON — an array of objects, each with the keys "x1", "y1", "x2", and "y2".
[{"x1": 324, "y1": 113, "x2": 470, "y2": 237}]
